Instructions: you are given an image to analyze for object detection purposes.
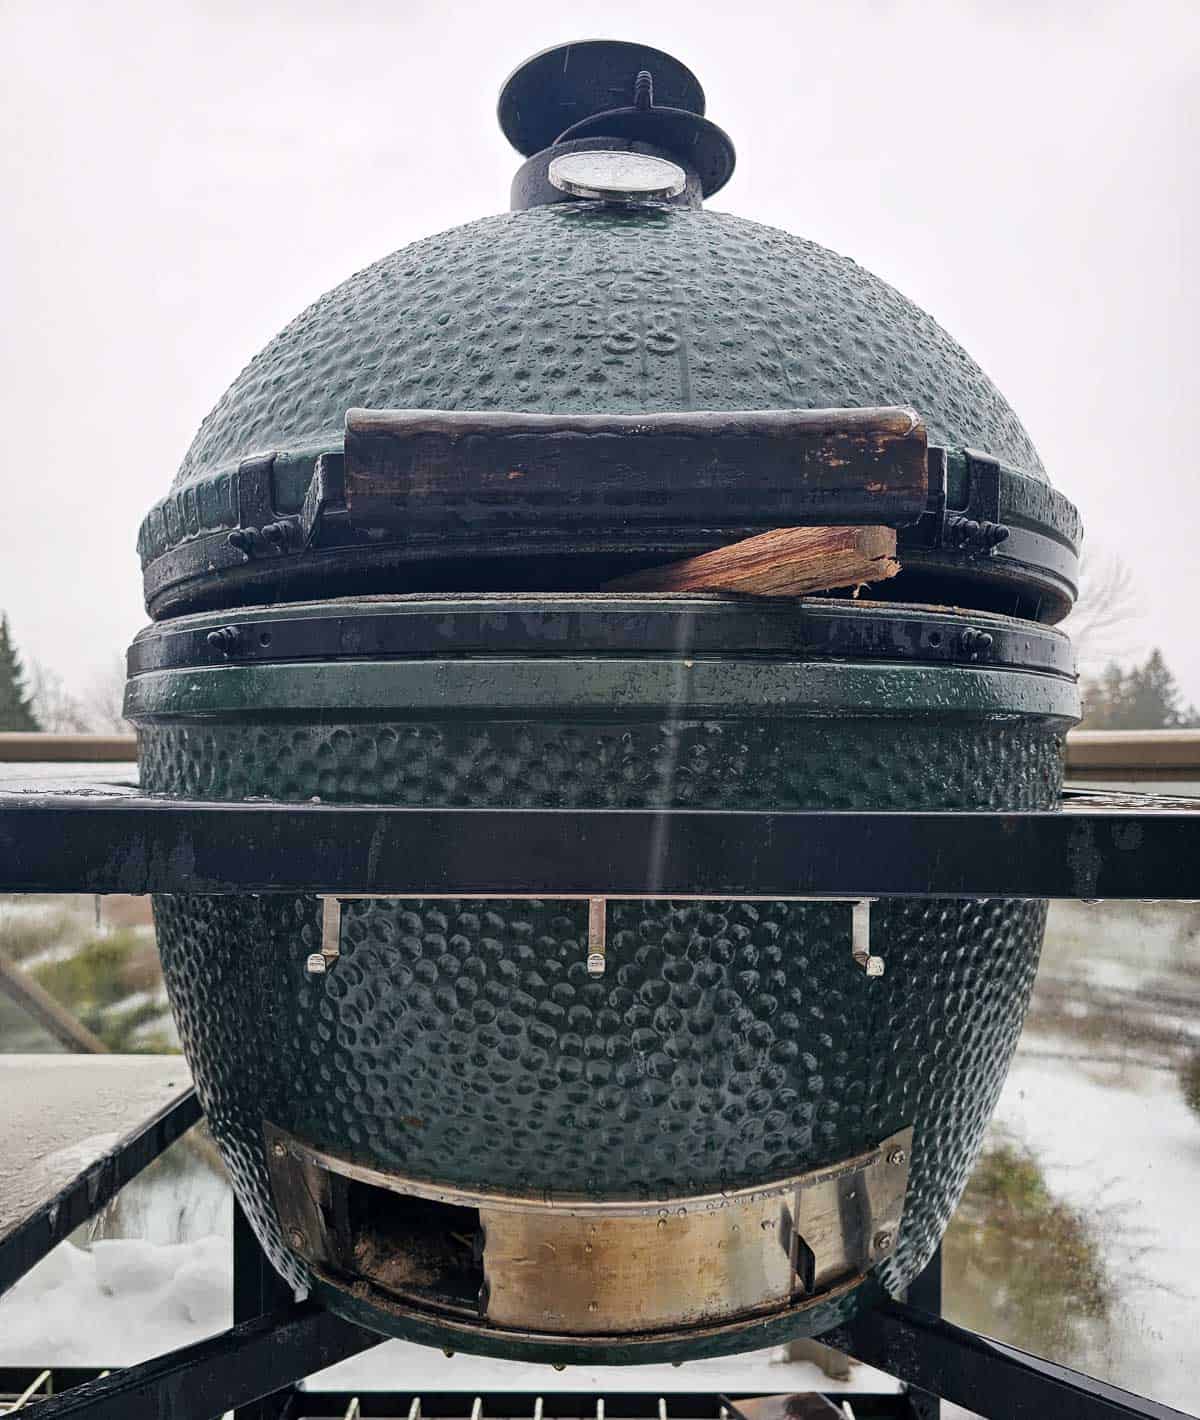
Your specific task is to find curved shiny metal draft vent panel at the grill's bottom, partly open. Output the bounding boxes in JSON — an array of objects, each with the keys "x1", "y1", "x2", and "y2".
[{"x1": 264, "y1": 1123, "x2": 912, "y2": 1338}]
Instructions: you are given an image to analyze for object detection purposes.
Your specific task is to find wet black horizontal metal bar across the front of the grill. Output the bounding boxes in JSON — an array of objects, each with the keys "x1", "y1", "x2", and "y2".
[{"x1": 0, "y1": 781, "x2": 1200, "y2": 899}]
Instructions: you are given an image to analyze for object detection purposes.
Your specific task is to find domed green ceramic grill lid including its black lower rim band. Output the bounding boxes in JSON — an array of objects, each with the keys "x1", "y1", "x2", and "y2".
[{"x1": 139, "y1": 41, "x2": 1081, "y2": 621}]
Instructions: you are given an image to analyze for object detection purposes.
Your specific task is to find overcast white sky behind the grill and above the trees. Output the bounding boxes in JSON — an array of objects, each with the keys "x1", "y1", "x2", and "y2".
[{"x1": 0, "y1": 0, "x2": 1200, "y2": 700}]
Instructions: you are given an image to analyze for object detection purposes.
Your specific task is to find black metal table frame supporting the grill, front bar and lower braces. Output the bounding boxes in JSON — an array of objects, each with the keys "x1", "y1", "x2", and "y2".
[{"x1": 0, "y1": 781, "x2": 1200, "y2": 1420}]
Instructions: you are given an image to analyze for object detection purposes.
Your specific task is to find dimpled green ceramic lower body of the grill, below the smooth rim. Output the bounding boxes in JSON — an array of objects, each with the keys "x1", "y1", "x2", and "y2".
[{"x1": 142, "y1": 687, "x2": 1068, "y2": 1362}]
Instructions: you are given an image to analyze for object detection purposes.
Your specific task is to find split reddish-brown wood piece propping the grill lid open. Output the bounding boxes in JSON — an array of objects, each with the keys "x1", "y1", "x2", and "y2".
[{"x1": 604, "y1": 527, "x2": 900, "y2": 596}]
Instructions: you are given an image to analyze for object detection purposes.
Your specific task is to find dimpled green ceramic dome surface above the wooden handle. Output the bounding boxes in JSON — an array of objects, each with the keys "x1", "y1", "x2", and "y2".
[{"x1": 175, "y1": 203, "x2": 1044, "y2": 488}]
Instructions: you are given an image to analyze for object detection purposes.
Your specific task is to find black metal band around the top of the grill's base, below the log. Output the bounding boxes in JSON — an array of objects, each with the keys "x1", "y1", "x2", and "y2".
[{"x1": 128, "y1": 592, "x2": 1075, "y2": 679}]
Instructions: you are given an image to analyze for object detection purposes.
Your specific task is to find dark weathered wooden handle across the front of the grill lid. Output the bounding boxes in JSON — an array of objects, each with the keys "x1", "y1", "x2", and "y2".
[{"x1": 344, "y1": 408, "x2": 929, "y2": 531}]
